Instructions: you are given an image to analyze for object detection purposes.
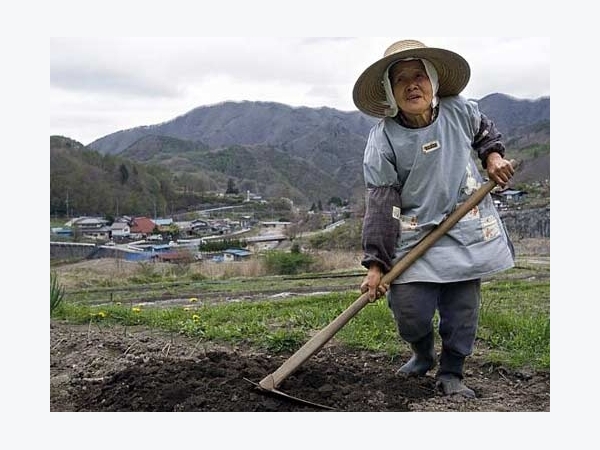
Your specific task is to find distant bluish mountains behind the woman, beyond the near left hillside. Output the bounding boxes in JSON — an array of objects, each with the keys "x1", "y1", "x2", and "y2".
[{"x1": 79, "y1": 94, "x2": 550, "y2": 205}]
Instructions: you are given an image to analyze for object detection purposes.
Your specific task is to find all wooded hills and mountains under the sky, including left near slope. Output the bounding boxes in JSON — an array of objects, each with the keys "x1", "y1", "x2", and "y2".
[{"x1": 50, "y1": 94, "x2": 550, "y2": 215}]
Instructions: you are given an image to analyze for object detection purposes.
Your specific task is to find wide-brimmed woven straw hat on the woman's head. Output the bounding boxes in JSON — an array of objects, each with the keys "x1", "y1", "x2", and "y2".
[{"x1": 352, "y1": 40, "x2": 471, "y2": 117}]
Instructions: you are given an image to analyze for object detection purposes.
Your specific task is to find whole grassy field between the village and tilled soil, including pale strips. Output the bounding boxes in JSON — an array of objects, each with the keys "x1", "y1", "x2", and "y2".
[{"x1": 51, "y1": 262, "x2": 550, "y2": 370}]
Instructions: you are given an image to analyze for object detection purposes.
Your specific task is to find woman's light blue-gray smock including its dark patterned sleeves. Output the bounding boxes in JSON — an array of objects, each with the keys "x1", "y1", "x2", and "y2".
[{"x1": 362, "y1": 96, "x2": 514, "y2": 283}]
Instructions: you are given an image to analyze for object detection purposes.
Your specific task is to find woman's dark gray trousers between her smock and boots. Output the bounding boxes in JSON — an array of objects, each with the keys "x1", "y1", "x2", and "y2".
[{"x1": 388, "y1": 279, "x2": 481, "y2": 360}]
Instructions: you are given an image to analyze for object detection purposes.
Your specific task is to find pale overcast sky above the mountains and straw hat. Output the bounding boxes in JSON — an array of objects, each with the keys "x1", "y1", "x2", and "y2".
[{"x1": 50, "y1": 36, "x2": 550, "y2": 145}]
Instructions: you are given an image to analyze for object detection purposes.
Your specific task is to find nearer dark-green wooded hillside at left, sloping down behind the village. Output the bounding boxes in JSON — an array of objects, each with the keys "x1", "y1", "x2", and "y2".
[{"x1": 50, "y1": 136, "x2": 298, "y2": 217}]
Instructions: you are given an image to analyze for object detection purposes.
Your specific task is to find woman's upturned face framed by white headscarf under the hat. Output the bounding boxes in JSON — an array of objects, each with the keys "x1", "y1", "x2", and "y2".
[{"x1": 389, "y1": 60, "x2": 433, "y2": 115}]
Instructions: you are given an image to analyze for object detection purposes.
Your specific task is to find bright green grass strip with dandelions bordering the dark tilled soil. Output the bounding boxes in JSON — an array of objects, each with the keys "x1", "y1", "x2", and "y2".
[{"x1": 52, "y1": 279, "x2": 550, "y2": 370}]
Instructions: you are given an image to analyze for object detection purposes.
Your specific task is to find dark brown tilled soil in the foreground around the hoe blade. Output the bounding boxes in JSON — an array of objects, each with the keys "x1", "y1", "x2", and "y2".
[{"x1": 50, "y1": 320, "x2": 550, "y2": 412}]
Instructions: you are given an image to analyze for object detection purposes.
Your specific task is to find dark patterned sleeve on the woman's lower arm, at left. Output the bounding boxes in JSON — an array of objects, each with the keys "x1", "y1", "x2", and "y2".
[{"x1": 361, "y1": 186, "x2": 401, "y2": 272}]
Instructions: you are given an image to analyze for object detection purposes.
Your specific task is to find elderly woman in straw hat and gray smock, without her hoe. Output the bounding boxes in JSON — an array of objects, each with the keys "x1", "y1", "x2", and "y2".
[{"x1": 353, "y1": 40, "x2": 514, "y2": 397}]
